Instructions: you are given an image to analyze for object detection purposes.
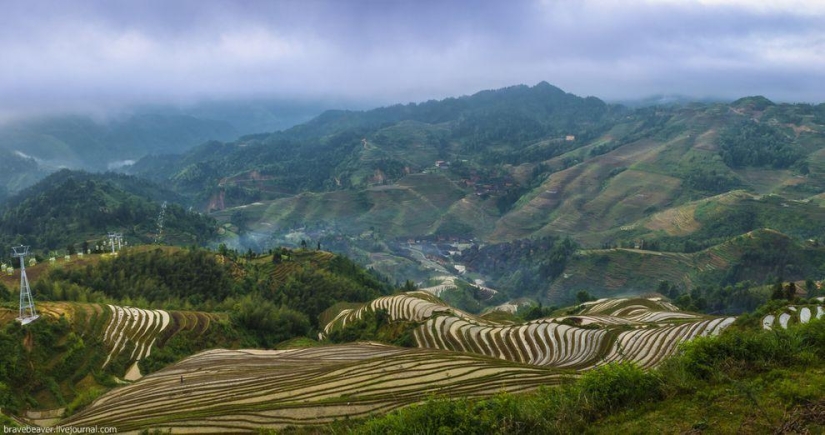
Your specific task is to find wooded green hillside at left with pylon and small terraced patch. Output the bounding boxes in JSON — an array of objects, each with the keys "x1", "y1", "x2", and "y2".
[{"x1": 0, "y1": 246, "x2": 390, "y2": 417}]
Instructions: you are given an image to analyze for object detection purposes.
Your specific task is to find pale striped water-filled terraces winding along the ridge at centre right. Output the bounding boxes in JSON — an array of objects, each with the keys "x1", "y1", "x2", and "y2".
[{"x1": 324, "y1": 292, "x2": 734, "y2": 370}]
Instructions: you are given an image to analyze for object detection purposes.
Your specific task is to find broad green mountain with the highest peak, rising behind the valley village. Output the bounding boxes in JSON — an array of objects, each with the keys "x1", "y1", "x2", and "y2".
[{"x1": 108, "y1": 83, "x2": 825, "y2": 301}]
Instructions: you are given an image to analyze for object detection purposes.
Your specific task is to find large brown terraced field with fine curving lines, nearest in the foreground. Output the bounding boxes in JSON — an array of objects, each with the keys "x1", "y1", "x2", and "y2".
[{"x1": 61, "y1": 343, "x2": 564, "y2": 433}]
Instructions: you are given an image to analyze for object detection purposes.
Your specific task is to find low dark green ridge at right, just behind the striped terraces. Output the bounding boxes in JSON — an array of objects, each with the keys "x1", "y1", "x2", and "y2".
[{"x1": 546, "y1": 230, "x2": 825, "y2": 301}]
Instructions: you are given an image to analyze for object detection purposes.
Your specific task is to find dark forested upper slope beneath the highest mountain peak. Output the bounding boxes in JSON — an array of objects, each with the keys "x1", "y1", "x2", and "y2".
[{"x1": 135, "y1": 83, "x2": 611, "y2": 203}]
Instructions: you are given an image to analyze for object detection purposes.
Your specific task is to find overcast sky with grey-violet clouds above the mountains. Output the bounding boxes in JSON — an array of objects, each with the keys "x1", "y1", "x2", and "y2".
[{"x1": 0, "y1": 0, "x2": 825, "y2": 119}]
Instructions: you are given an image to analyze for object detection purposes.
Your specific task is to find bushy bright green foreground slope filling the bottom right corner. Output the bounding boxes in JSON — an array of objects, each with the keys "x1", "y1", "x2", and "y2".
[{"x1": 338, "y1": 312, "x2": 825, "y2": 434}]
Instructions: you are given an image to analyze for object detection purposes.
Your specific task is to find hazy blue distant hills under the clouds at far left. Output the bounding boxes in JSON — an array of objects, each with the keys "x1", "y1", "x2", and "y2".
[{"x1": 0, "y1": 99, "x2": 336, "y2": 195}]
